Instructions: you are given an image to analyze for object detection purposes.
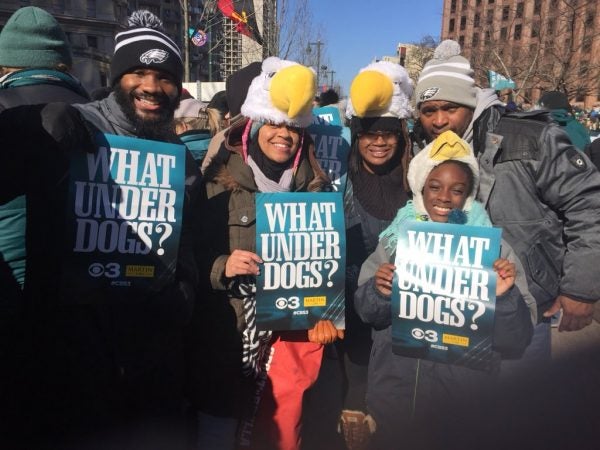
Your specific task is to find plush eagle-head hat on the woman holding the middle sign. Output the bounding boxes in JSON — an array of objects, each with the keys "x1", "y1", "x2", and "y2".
[{"x1": 241, "y1": 56, "x2": 316, "y2": 128}]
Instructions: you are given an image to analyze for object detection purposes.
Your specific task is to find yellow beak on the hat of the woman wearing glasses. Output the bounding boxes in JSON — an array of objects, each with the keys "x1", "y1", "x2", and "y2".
[{"x1": 350, "y1": 70, "x2": 394, "y2": 117}]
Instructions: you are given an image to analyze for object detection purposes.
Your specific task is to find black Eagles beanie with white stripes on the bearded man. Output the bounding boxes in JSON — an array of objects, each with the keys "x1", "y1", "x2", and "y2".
[{"x1": 110, "y1": 10, "x2": 183, "y2": 89}]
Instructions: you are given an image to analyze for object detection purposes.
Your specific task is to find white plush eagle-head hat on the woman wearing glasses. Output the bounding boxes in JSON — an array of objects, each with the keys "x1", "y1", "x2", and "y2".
[{"x1": 346, "y1": 61, "x2": 413, "y2": 119}]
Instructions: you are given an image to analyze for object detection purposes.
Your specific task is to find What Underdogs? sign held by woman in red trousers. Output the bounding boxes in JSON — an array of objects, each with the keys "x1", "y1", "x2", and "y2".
[{"x1": 256, "y1": 192, "x2": 346, "y2": 330}]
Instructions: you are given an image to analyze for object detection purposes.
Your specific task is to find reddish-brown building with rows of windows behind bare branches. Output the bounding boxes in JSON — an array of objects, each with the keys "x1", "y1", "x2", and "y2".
[{"x1": 441, "y1": 0, "x2": 600, "y2": 108}]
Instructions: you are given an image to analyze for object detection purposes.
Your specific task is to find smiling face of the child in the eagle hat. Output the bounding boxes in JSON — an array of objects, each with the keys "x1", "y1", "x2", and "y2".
[{"x1": 423, "y1": 161, "x2": 471, "y2": 222}]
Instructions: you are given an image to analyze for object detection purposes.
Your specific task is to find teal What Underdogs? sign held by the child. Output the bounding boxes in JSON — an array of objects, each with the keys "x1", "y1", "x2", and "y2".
[{"x1": 392, "y1": 221, "x2": 502, "y2": 370}]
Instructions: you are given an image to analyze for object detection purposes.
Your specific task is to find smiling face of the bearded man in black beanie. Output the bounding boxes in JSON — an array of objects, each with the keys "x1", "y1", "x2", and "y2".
[{"x1": 119, "y1": 67, "x2": 179, "y2": 120}]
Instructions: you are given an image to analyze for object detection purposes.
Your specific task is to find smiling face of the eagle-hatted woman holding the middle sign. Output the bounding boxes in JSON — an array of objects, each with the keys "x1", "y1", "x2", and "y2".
[{"x1": 258, "y1": 124, "x2": 302, "y2": 163}]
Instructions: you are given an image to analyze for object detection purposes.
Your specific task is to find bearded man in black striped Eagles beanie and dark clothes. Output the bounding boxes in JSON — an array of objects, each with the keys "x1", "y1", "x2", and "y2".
[{"x1": 0, "y1": 11, "x2": 200, "y2": 449}]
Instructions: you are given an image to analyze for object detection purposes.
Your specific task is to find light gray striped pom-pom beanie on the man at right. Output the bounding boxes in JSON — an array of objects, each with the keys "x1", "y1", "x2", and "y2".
[{"x1": 415, "y1": 39, "x2": 477, "y2": 109}]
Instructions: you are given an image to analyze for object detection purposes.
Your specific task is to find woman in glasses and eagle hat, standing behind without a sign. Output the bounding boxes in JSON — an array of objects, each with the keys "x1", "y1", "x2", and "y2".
[{"x1": 336, "y1": 61, "x2": 413, "y2": 450}]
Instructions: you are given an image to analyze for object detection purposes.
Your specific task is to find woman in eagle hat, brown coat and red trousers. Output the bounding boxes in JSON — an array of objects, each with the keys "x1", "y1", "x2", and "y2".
[{"x1": 189, "y1": 57, "x2": 343, "y2": 449}]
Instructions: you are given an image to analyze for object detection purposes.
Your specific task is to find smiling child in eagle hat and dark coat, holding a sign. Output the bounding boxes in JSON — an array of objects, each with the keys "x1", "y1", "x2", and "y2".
[{"x1": 354, "y1": 131, "x2": 536, "y2": 450}]
